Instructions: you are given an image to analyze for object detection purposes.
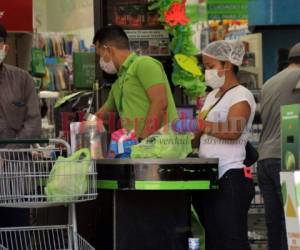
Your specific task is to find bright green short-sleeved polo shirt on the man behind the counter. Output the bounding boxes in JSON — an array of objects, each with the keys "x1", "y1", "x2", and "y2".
[{"x1": 105, "y1": 53, "x2": 178, "y2": 135}]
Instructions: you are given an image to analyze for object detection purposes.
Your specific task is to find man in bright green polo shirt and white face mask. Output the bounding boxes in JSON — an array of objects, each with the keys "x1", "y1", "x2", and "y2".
[{"x1": 94, "y1": 26, "x2": 177, "y2": 138}]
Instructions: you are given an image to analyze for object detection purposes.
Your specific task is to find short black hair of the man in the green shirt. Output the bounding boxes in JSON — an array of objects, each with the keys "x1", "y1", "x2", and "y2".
[{"x1": 93, "y1": 25, "x2": 129, "y2": 49}]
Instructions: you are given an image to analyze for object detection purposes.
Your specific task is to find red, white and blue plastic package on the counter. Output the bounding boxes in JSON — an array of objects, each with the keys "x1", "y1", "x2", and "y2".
[{"x1": 108, "y1": 129, "x2": 138, "y2": 158}]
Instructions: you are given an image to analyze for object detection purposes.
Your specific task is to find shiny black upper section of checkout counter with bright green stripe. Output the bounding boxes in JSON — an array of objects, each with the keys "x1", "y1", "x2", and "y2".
[{"x1": 97, "y1": 158, "x2": 218, "y2": 191}]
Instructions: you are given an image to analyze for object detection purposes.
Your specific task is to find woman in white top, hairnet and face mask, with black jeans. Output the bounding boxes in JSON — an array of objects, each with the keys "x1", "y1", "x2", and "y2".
[{"x1": 193, "y1": 41, "x2": 256, "y2": 250}]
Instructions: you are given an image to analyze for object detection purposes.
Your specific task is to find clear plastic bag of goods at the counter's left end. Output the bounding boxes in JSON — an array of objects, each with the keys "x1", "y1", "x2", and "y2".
[{"x1": 70, "y1": 120, "x2": 107, "y2": 160}]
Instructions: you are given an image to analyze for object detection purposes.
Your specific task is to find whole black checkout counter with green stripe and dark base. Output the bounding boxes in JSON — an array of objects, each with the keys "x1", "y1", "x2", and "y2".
[{"x1": 97, "y1": 158, "x2": 218, "y2": 250}]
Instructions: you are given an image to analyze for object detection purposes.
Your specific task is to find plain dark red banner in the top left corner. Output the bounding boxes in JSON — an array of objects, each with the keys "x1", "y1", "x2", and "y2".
[{"x1": 0, "y1": 0, "x2": 33, "y2": 32}]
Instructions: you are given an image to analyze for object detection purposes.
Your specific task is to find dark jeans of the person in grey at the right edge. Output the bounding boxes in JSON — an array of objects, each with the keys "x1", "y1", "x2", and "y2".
[{"x1": 257, "y1": 159, "x2": 288, "y2": 250}]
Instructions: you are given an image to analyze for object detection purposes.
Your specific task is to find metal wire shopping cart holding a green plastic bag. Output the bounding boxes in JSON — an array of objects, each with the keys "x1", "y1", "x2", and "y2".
[{"x1": 0, "y1": 139, "x2": 97, "y2": 250}]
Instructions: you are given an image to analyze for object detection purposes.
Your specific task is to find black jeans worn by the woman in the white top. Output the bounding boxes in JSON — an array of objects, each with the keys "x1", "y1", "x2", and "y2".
[{"x1": 193, "y1": 169, "x2": 254, "y2": 250}]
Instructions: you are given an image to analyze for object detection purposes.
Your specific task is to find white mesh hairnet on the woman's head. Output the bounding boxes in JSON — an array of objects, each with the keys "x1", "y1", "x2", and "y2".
[{"x1": 202, "y1": 40, "x2": 245, "y2": 66}]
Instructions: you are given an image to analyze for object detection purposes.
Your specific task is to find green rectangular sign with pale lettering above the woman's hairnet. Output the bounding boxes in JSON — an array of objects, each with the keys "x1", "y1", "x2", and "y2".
[{"x1": 207, "y1": 0, "x2": 248, "y2": 20}]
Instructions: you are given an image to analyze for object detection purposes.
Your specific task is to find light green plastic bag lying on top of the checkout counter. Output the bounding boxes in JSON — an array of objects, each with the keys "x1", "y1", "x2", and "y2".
[{"x1": 131, "y1": 131, "x2": 192, "y2": 159}]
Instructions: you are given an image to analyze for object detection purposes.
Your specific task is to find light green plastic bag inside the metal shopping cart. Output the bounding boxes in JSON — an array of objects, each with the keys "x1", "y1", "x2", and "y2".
[{"x1": 45, "y1": 148, "x2": 91, "y2": 202}]
